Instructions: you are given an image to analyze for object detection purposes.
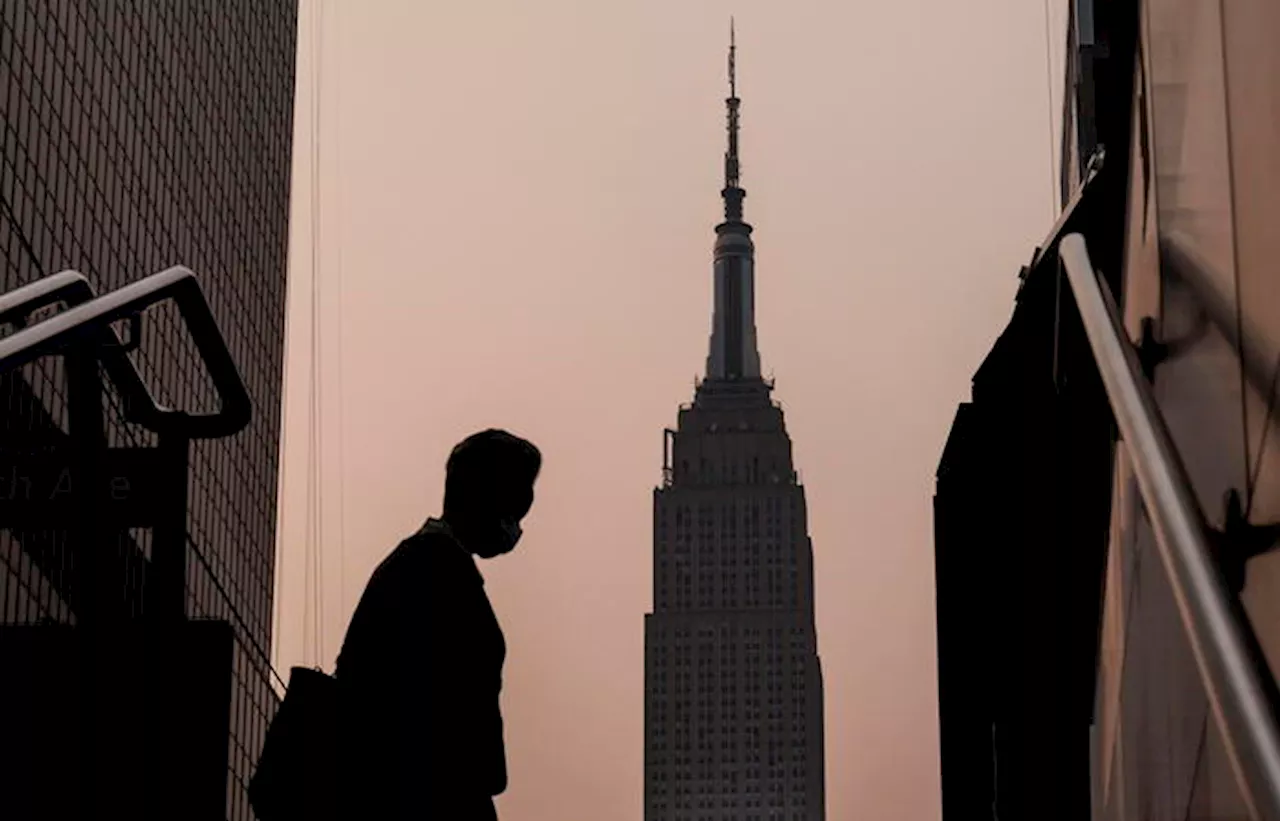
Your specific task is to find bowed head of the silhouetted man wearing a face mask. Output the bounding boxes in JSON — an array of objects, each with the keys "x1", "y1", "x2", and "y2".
[{"x1": 444, "y1": 429, "x2": 543, "y2": 558}]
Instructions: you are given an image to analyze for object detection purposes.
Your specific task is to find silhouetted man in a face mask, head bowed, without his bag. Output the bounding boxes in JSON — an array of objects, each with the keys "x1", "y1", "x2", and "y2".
[{"x1": 335, "y1": 430, "x2": 541, "y2": 821}]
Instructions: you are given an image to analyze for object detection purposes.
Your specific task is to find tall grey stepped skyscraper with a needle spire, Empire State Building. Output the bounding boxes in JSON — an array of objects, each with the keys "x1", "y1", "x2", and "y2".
[{"x1": 645, "y1": 25, "x2": 826, "y2": 821}]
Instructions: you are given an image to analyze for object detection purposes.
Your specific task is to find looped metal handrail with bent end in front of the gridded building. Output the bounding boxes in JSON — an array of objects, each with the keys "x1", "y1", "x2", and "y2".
[{"x1": 0, "y1": 266, "x2": 252, "y2": 439}]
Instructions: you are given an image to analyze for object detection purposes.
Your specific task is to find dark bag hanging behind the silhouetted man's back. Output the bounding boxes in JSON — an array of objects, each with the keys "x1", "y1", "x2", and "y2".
[{"x1": 248, "y1": 667, "x2": 339, "y2": 821}]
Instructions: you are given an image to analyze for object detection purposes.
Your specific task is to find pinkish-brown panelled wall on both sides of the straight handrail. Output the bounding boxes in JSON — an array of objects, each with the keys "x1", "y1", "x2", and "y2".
[{"x1": 1094, "y1": 0, "x2": 1280, "y2": 820}]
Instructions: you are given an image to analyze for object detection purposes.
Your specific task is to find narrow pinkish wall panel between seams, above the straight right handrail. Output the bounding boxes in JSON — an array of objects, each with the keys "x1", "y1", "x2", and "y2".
[{"x1": 1144, "y1": 0, "x2": 1247, "y2": 524}]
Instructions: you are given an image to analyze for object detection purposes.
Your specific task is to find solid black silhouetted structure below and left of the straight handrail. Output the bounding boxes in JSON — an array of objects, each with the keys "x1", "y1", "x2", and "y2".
[{"x1": 934, "y1": 222, "x2": 1111, "y2": 821}]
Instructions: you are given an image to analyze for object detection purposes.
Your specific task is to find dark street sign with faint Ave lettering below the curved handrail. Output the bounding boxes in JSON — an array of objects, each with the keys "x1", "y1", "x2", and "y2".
[{"x1": 0, "y1": 447, "x2": 175, "y2": 530}]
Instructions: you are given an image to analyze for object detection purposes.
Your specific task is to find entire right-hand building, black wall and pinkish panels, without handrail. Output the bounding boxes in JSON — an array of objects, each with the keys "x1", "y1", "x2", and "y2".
[{"x1": 934, "y1": 0, "x2": 1280, "y2": 821}]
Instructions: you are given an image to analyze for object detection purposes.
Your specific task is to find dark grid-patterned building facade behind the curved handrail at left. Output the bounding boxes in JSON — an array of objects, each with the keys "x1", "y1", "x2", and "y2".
[{"x1": 0, "y1": 0, "x2": 297, "y2": 820}]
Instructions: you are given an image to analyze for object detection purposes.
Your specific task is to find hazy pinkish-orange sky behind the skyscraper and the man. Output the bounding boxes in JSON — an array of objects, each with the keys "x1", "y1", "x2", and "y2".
[{"x1": 276, "y1": 0, "x2": 1065, "y2": 821}]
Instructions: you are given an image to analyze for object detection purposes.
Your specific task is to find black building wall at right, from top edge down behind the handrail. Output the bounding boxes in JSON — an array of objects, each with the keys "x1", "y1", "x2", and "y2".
[{"x1": 934, "y1": 0, "x2": 1138, "y2": 821}]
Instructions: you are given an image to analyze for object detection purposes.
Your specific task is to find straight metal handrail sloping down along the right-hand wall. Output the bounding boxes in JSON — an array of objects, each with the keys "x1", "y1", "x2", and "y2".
[{"x1": 1059, "y1": 233, "x2": 1280, "y2": 821}]
